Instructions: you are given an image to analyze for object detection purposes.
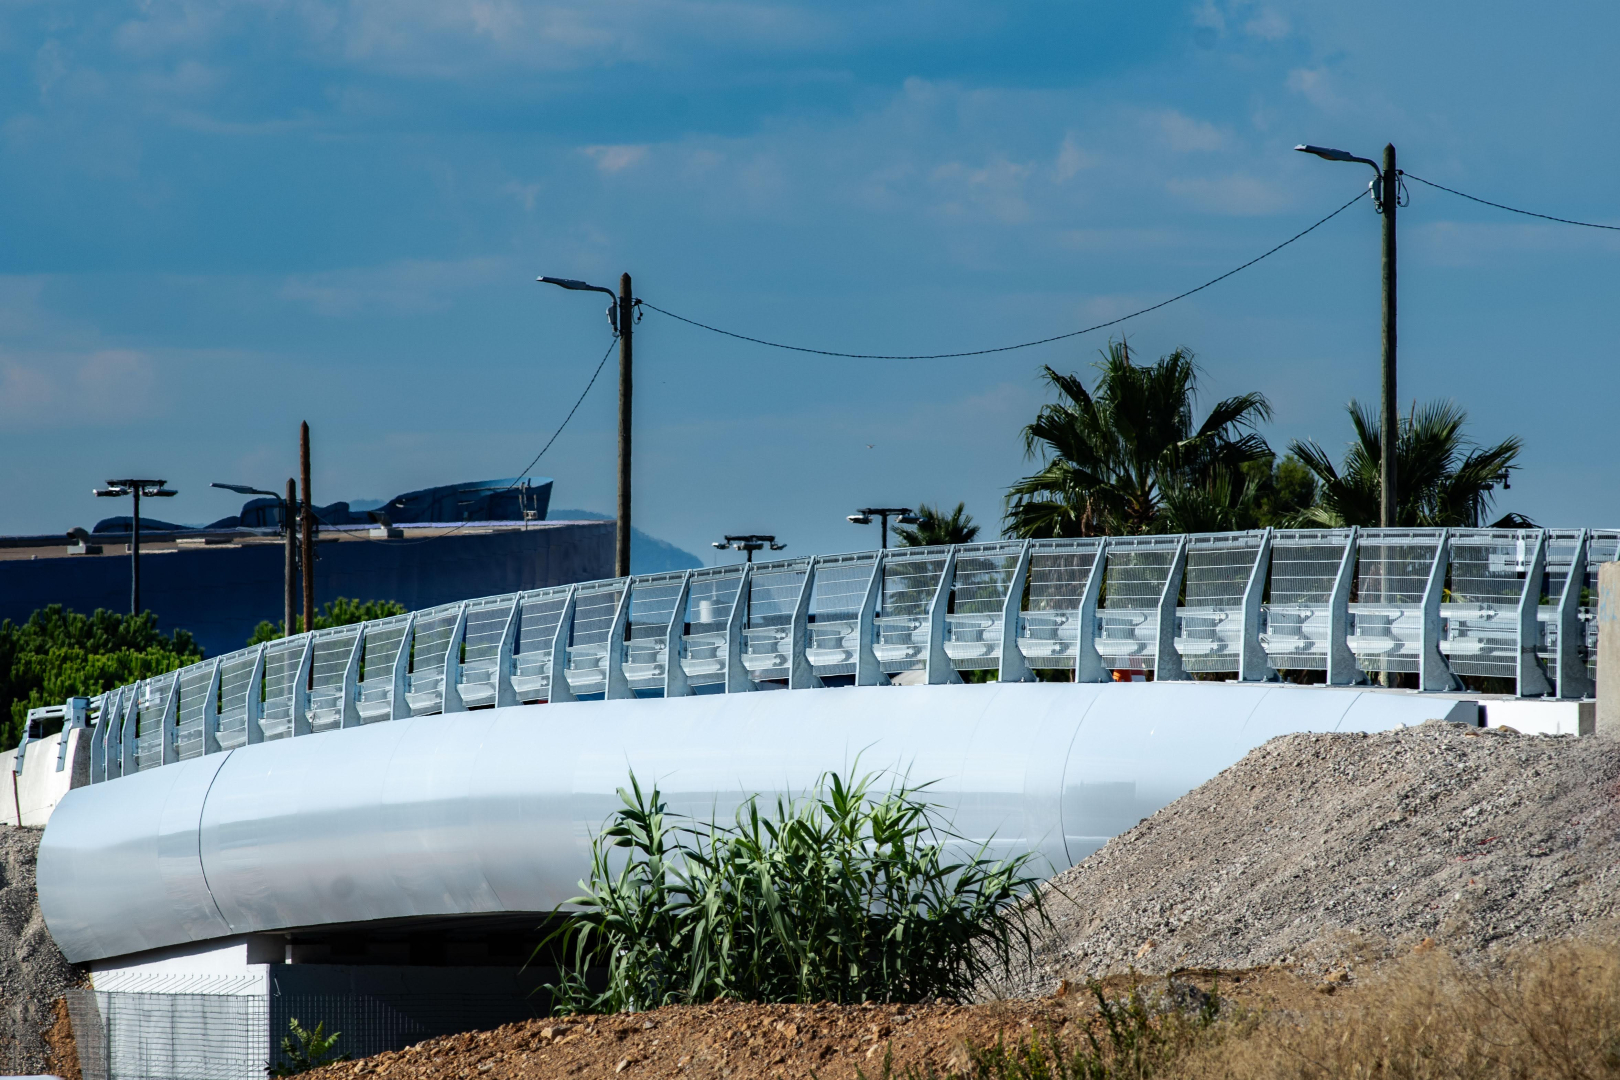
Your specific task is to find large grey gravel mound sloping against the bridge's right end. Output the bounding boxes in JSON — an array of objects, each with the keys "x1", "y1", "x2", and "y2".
[{"x1": 998, "y1": 722, "x2": 1620, "y2": 996}]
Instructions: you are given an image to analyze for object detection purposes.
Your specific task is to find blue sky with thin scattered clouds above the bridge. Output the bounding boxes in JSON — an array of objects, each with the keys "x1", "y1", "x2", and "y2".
[{"x1": 0, "y1": 0, "x2": 1620, "y2": 554}]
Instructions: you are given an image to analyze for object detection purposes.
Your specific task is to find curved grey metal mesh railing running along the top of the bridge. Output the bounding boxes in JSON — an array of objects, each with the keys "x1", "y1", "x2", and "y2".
[{"x1": 91, "y1": 528, "x2": 1620, "y2": 782}]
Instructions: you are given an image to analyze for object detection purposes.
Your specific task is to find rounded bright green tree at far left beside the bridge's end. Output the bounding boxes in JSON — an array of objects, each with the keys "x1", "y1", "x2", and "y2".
[{"x1": 0, "y1": 604, "x2": 203, "y2": 750}]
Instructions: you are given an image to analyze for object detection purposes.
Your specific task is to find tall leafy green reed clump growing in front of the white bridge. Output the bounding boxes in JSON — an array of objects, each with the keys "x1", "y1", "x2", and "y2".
[{"x1": 536, "y1": 772, "x2": 1045, "y2": 1012}]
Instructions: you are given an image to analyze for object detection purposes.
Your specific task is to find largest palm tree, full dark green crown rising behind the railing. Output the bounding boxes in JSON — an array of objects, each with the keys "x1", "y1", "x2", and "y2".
[{"x1": 1006, "y1": 340, "x2": 1272, "y2": 538}]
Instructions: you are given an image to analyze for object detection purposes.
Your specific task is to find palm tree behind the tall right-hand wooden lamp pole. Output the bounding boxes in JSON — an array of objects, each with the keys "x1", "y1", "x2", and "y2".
[{"x1": 1290, "y1": 402, "x2": 1524, "y2": 528}]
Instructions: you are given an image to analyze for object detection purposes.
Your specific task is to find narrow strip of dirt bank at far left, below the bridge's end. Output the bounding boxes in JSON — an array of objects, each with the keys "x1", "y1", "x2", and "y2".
[{"x1": 0, "y1": 826, "x2": 83, "y2": 1075}]
